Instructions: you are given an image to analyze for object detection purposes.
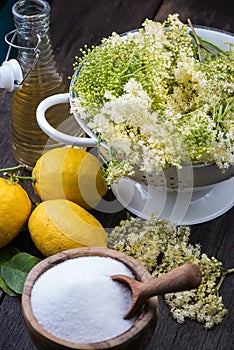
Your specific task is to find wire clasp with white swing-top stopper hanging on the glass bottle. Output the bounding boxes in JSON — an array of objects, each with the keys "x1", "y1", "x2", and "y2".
[{"x1": 0, "y1": 29, "x2": 41, "y2": 92}]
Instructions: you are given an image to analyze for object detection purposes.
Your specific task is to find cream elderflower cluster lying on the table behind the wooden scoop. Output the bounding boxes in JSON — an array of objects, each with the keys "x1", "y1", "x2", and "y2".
[{"x1": 108, "y1": 217, "x2": 227, "y2": 329}]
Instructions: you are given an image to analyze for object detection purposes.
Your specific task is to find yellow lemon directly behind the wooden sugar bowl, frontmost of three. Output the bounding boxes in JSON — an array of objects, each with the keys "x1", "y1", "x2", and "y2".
[{"x1": 28, "y1": 199, "x2": 107, "y2": 256}]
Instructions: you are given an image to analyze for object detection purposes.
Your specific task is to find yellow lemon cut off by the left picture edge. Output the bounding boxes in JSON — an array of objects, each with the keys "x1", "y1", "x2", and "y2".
[{"x1": 0, "y1": 178, "x2": 32, "y2": 248}]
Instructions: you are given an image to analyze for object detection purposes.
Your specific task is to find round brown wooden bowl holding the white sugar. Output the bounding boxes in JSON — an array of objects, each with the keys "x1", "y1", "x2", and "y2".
[{"x1": 22, "y1": 247, "x2": 158, "y2": 350}]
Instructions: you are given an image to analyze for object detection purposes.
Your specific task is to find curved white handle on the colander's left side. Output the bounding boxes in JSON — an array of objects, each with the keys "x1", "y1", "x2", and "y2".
[{"x1": 36, "y1": 93, "x2": 97, "y2": 147}]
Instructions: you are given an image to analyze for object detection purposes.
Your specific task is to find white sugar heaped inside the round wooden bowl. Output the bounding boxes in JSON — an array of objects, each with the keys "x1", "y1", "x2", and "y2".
[{"x1": 31, "y1": 256, "x2": 135, "y2": 343}]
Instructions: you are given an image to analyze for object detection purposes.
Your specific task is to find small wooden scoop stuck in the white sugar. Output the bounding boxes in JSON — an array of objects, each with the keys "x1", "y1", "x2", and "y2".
[{"x1": 111, "y1": 263, "x2": 202, "y2": 319}]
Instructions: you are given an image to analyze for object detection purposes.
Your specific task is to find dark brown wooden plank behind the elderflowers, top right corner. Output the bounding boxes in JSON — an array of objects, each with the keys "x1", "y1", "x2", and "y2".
[{"x1": 155, "y1": 0, "x2": 234, "y2": 32}]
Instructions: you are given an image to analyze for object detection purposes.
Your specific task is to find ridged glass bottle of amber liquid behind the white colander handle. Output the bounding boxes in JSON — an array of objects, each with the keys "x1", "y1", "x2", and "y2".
[{"x1": 12, "y1": 0, "x2": 80, "y2": 168}]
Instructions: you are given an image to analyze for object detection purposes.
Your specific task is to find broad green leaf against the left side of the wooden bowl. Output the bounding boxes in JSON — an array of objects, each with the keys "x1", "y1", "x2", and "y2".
[{"x1": 1, "y1": 253, "x2": 41, "y2": 294}]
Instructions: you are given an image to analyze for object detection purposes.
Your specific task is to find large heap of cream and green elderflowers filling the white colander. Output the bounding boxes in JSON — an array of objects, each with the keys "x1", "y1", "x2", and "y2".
[{"x1": 72, "y1": 15, "x2": 234, "y2": 183}]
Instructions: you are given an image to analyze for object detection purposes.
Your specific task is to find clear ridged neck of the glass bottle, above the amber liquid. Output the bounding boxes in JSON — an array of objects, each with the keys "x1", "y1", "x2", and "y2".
[{"x1": 12, "y1": 0, "x2": 61, "y2": 85}]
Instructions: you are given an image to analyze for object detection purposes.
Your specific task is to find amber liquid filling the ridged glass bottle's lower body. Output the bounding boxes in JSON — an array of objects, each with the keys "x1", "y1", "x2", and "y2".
[{"x1": 12, "y1": 75, "x2": 77, "y2": 168}]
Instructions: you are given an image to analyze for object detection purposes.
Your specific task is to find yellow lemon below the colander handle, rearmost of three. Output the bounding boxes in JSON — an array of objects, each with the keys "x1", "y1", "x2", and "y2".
[{"x1": 32, "y1": 147, "x2": 107, "y2": 209}]
